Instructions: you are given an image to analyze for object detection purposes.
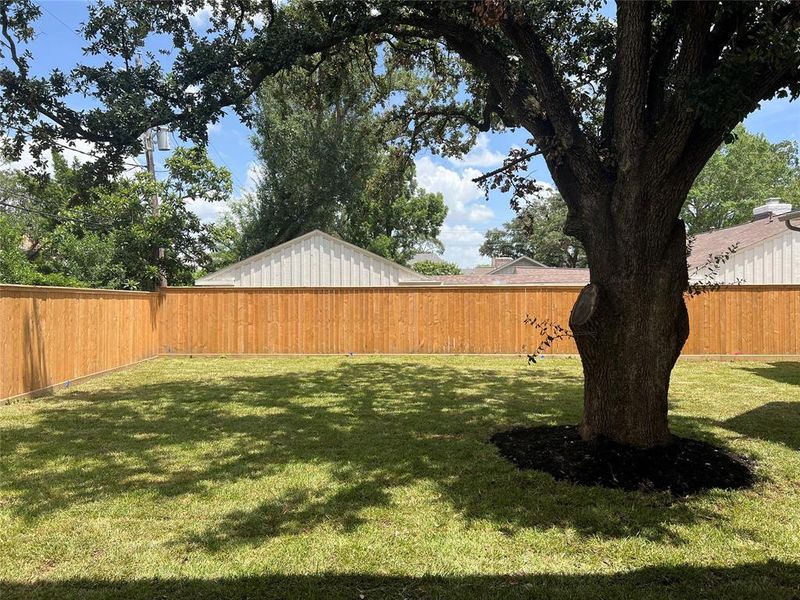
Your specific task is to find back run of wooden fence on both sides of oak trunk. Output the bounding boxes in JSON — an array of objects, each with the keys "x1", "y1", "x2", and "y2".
[{"x1": 160, "y1": 286, "x2": 800, "y2": 355}]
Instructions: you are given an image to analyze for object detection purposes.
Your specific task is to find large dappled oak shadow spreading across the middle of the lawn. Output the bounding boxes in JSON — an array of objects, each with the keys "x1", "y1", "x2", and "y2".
[{"x1": 0, "y1": 360, "x2": 744, "y2": 550}]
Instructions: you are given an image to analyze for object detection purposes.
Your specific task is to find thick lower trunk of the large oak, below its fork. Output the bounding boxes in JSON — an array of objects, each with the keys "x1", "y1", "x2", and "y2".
[{"x1": 570, "y1": 204, "x2": 689, "y2": 447}]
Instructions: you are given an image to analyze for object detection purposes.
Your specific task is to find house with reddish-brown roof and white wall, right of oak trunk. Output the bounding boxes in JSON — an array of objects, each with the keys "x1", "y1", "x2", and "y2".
[{"x1": 688, "y1": 201, "x2": 800, "y2": 285}]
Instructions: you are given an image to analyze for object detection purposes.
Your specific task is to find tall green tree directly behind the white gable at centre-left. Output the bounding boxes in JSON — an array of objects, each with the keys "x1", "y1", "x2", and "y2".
[{"x1": 238, "y1": 48, "x2": 447, "y2": 263}]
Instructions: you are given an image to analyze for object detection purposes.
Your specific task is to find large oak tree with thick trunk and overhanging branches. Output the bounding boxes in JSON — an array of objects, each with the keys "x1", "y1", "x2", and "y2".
[{"x1": 0, "y1": 0, "x2": 800, "y2": 446}]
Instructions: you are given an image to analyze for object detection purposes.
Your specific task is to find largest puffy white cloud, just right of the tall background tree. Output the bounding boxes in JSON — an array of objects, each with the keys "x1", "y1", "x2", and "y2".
[{"x1": 415, "y1": 156, "x2": 494, "y2": 223}]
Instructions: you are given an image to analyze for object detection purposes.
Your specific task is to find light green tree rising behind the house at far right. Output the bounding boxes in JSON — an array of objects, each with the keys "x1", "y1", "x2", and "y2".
[{"x1": 681, "y1": 125, "x2": 800, "y2": 235}]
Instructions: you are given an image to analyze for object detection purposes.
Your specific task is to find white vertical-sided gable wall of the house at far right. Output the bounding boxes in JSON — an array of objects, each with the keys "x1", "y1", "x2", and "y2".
[{"x1": 692, "y1": 228, "x2": 800, "y2": 285}]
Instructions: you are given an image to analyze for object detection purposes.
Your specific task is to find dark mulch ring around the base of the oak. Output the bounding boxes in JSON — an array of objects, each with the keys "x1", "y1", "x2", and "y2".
[{"x1": 490, "y1": 425, "x2": 755, "y2": 496}]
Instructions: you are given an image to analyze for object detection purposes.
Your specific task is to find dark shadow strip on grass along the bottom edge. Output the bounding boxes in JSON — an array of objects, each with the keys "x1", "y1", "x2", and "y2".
[{"x1": 0, "y1": 561, "x2": 800, "y2": 600}]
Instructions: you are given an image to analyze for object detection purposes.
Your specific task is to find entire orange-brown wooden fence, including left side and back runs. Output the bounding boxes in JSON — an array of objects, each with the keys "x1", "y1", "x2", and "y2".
[{"x1": 0, "y1": 286, "x2": 800, "y2": 398}]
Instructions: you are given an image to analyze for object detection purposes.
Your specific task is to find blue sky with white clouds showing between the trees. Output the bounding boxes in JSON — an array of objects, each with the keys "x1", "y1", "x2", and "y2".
[{"x1": 17, "y1": 0, "x2": 800, "y2": 267}]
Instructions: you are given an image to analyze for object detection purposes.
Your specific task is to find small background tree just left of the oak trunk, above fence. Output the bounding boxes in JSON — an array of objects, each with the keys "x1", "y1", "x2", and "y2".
[{"x1": 480, "y1": 194, "x2": 587, "y2": 267}]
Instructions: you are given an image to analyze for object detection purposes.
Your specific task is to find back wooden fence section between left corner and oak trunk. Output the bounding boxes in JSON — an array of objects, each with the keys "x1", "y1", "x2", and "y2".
[{"x1": 161, "y1": 287, "x2": 580, "y2": 354}]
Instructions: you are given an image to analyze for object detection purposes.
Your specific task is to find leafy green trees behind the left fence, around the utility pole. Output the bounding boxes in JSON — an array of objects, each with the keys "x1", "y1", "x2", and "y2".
[{"x1": 2, "y1": 148, "x2": 231, "y2": 290}]
